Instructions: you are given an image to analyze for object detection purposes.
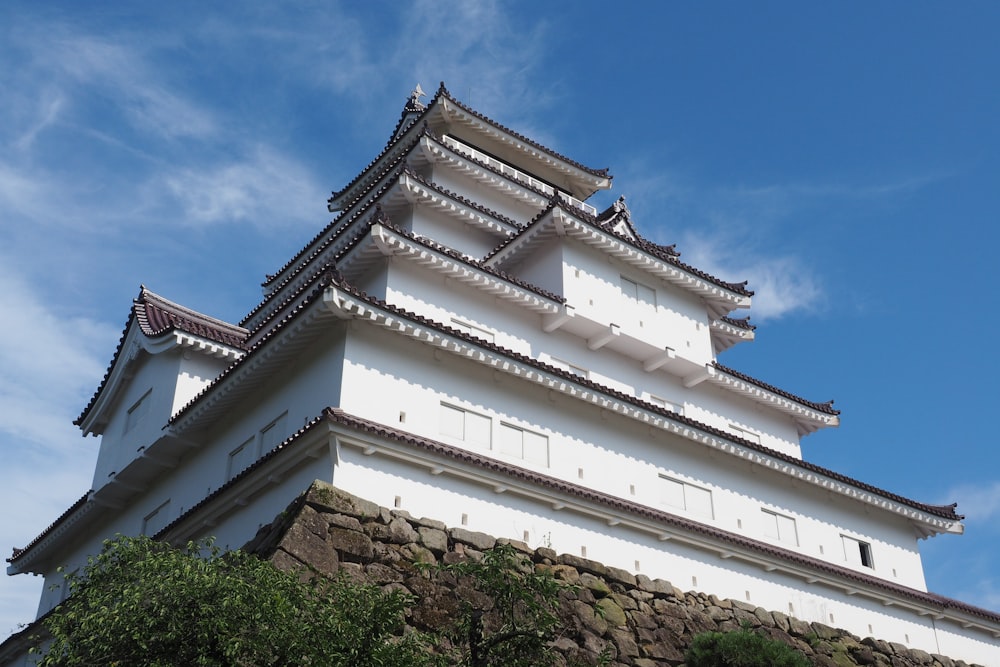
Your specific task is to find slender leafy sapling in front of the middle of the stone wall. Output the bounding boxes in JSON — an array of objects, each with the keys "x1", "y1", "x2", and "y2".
[{"x1": 440, "y1": 545, "x2": 573, "y2": 667}]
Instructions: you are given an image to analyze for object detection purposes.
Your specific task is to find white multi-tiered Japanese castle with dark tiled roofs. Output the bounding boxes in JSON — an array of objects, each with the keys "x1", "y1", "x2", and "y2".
[{"x1": 0, "y1": 84, "x2": 1000, "y2": 665}]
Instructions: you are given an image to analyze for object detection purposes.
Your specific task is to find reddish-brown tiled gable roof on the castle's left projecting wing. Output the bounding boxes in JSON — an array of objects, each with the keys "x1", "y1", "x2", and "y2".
[{"x1": 73, "y1": 285, "x2": 248, "y2": 426}]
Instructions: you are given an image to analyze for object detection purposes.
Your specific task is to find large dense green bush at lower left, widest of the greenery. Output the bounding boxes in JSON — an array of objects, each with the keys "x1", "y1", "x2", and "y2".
[{"x1": 40, "y1": 536, "x2": 437, "y2": 667}]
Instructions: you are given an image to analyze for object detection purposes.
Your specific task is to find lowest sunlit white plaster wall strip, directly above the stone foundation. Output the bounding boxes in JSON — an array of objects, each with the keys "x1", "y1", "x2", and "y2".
[{"x1": 334, "y1": 447, "x2": 1000, "y2": 665}]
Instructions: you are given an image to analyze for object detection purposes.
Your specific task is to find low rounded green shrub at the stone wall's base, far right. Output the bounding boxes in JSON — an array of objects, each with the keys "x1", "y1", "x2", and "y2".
[{"x1": 684, "y1": 627, "x2": 811, "y2": 667}]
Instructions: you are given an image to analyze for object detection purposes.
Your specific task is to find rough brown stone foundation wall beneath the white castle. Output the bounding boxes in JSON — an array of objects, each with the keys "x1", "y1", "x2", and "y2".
[{"x1": 245, "y1": 482, "x2": 984, "y2": 667}]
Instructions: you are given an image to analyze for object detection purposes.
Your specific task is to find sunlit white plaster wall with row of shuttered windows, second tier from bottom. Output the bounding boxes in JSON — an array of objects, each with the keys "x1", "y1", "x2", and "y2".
[{"x1": 332, "y1": 329, "x2": 924, "y2": 589}]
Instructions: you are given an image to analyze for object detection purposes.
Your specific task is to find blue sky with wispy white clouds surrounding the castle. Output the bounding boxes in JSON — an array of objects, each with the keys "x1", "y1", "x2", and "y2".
[{"x1": 0, "y1": 0, "x2": 1000, "y2": 638}]
